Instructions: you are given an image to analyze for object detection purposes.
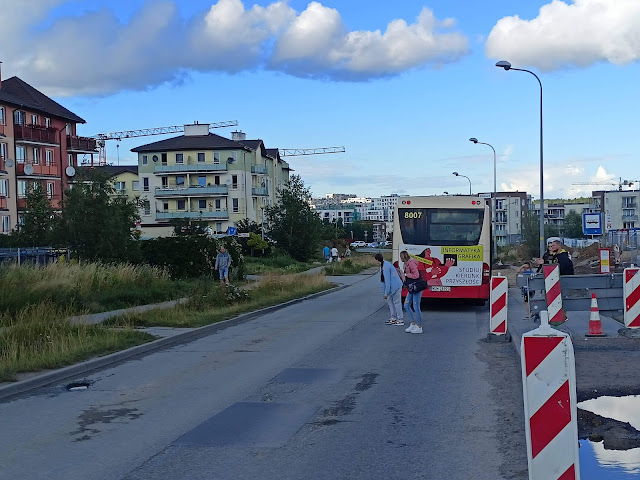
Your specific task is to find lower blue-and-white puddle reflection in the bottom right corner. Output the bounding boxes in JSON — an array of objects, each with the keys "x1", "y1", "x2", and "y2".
[{"x1": 579, "y1": 440, "x2": 640, "y2": 480}]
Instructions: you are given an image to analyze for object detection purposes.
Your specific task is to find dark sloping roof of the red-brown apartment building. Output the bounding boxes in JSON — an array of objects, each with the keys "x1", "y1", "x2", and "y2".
[{"x1": 0, "y1": 77, "x2": 87, "y2": 123}]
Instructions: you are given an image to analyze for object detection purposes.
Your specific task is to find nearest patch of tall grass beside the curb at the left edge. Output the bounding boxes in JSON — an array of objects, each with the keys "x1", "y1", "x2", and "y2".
[{"x1": 0, "y1": 302, "x2": 154, "y2": 382}]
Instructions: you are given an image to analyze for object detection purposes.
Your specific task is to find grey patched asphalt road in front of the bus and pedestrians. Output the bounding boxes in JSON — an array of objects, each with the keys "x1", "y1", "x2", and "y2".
[{"x1": 0, "y1": 275, "x2": 527, "y2": 480}]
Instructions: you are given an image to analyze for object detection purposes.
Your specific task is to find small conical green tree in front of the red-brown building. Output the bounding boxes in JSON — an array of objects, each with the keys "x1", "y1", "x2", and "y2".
[{"x1": 18, "y1": 182, "x2": 55, "y2": 247}]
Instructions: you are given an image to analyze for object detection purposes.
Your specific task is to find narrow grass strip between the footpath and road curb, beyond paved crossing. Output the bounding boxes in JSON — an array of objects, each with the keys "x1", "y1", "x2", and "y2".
[{"x1": 108, "y1": 274, "x2": 333, "y2": 327}]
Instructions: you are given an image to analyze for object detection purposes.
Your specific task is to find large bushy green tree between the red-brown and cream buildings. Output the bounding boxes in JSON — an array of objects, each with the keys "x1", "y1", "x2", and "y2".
[{"x1": 58, "y1": 170, "x2": 139, "y2": 262}]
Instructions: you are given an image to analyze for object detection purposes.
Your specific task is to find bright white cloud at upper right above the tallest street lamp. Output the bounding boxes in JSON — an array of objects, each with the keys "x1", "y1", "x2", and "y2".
[{"x1": 485, "y1": 0, "x2": 640, "y2": 71}]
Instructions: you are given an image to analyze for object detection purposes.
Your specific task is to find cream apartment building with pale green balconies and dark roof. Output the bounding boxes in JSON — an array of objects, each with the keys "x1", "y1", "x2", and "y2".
[{"x1": 131, "y1": 123, "x2": 290, "y2": 237}]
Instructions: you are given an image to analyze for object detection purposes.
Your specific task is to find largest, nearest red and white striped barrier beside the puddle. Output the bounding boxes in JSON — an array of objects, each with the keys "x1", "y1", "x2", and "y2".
[{"x1": 520, "y1": 310, "x2": 580, "y2": 480}]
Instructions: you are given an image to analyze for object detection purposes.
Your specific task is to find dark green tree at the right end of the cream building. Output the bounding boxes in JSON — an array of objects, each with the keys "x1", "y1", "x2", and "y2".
[{"x1": 265, "y1": 175, "x2": 322, "y2": 261}]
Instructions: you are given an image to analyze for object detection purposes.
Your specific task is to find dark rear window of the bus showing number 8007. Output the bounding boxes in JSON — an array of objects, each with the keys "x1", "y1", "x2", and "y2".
[{"x1": 398, "y1": 208, "x2": 484, "y2": 245}]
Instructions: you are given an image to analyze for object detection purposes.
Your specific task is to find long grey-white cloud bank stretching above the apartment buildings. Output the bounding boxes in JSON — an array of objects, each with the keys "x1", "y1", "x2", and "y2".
[{"x1": 0, "y1": 0, "x2": 468, "y2": 95}]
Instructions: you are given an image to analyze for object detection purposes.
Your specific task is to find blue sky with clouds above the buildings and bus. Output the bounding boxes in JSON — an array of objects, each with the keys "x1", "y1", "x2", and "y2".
[{"x1": 0, "y1": 0, "x2": 640, "y2": 198}]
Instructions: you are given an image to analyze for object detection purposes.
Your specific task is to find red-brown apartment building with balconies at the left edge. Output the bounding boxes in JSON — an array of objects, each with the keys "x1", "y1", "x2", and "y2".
[{"x1": 0, "y1": 66, "x2": 98, "y2": 234}]
